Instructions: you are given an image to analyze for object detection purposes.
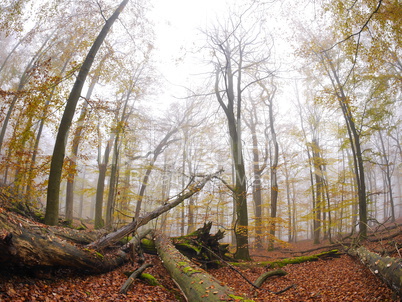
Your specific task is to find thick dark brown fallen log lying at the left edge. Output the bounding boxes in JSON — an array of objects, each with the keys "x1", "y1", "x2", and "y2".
[{"x1": 0, "y1": 208, "x2": 128, "y2": 273}]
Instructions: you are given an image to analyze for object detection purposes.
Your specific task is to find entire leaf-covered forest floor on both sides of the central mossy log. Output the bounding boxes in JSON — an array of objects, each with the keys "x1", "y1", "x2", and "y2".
[{"x1": 0, "y1": 221, "x2": 402, "y2": 302}]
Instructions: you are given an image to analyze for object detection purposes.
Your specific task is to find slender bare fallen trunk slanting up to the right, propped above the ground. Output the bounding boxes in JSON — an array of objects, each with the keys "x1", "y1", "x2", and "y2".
[{"x1": 87, "y1": 171, "x2": 221, "y2": 250}]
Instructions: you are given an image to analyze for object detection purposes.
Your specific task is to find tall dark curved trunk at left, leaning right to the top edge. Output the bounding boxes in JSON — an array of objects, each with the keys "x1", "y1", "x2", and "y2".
[{"x1": 45, "y1": 0, "x2": 128, "y2": 225}]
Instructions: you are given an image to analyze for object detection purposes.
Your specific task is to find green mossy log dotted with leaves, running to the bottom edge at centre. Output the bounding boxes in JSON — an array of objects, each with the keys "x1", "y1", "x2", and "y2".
[{"x1": 155, "y1": 233, "x2": 253, "y2": 302}]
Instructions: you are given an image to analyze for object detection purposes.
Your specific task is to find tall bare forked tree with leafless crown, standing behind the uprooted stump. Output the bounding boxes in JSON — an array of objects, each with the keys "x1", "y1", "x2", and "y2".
[{"x1": 205, "y1": 5, "x2": 270, "y2": 259}]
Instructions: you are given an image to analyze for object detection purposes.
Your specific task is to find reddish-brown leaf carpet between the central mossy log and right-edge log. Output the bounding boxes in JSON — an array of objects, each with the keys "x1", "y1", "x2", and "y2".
[{"x1": 210, "y1": 255, "x2": 399, "y2": 302}]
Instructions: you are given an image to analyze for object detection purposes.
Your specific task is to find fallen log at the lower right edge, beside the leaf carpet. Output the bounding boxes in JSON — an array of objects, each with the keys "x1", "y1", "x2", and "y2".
[{"x1": 348, "y1": 246, "x2": 402, "y2": 298}]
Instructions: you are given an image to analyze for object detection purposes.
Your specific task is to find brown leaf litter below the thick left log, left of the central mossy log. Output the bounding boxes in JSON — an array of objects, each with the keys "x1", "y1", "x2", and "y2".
[{"x1": 0, "y1": 255, "x2": 180, "y2": 302}]
